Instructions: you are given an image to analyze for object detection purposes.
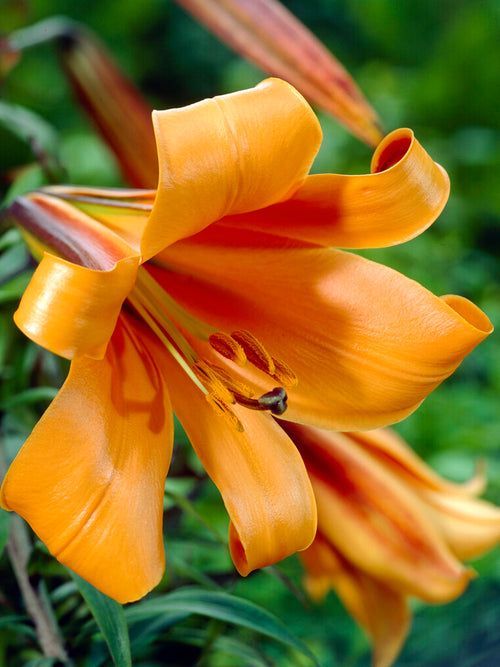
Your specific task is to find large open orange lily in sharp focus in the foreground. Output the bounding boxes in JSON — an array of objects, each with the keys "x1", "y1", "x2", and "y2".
[{"x1": 1, "y1": 79, "x2": 491, "y2": 602}]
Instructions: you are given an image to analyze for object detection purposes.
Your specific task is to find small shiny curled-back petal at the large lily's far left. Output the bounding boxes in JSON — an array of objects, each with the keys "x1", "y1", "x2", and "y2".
[{"x1": 14, "y1": 253, "x2": 139, "y2": 359}]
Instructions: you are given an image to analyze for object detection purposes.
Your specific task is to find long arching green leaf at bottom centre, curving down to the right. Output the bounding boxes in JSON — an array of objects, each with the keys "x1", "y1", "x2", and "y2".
[{"x1": 125, "y1": 587, "x2": 318, "y2": 665}]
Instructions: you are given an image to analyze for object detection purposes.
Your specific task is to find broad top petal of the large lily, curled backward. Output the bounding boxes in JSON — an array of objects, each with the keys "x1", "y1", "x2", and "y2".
[{"x1": 142, "y1": 79, "x2": 321, "y2": 258}]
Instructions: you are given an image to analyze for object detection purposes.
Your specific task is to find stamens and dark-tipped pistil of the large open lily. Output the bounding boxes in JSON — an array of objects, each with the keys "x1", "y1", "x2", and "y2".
[{"x1": 128, "y1": 266, "x2": 297, "y2": 431}]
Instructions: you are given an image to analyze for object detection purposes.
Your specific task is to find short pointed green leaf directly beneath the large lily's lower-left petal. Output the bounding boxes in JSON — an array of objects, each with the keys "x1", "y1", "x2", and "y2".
[{"x1": 70, "y1": 570, "x2": 132, "y2": 667}]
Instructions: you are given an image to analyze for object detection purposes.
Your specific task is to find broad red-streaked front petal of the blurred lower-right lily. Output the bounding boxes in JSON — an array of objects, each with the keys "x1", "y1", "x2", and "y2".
[{"x1": 281, "y1": 422, "x2": 471, "y2": 602}]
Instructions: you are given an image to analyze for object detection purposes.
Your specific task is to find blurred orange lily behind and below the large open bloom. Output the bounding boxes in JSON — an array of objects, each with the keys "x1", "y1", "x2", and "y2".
[{"x1": 282, "y1": 422, "x2": 500, "y2": 667}]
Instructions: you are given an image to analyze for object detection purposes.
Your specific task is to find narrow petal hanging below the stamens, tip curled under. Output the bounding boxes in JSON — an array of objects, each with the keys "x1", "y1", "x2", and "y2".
[{"x1": 158, "y1": 344, "x2": 316, "y2": 576}]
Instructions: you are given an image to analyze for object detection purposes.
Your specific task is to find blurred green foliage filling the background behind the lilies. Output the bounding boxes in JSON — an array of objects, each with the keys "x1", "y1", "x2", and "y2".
[{"x1": 0, "y1": 0, "x2": 500, "y2": 667}]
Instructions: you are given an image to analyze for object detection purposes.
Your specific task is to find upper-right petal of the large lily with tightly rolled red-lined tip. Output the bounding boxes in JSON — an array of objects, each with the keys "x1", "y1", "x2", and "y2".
[{"x1": 221, "y1": 129, "x2": 450, "y2": 248}]
